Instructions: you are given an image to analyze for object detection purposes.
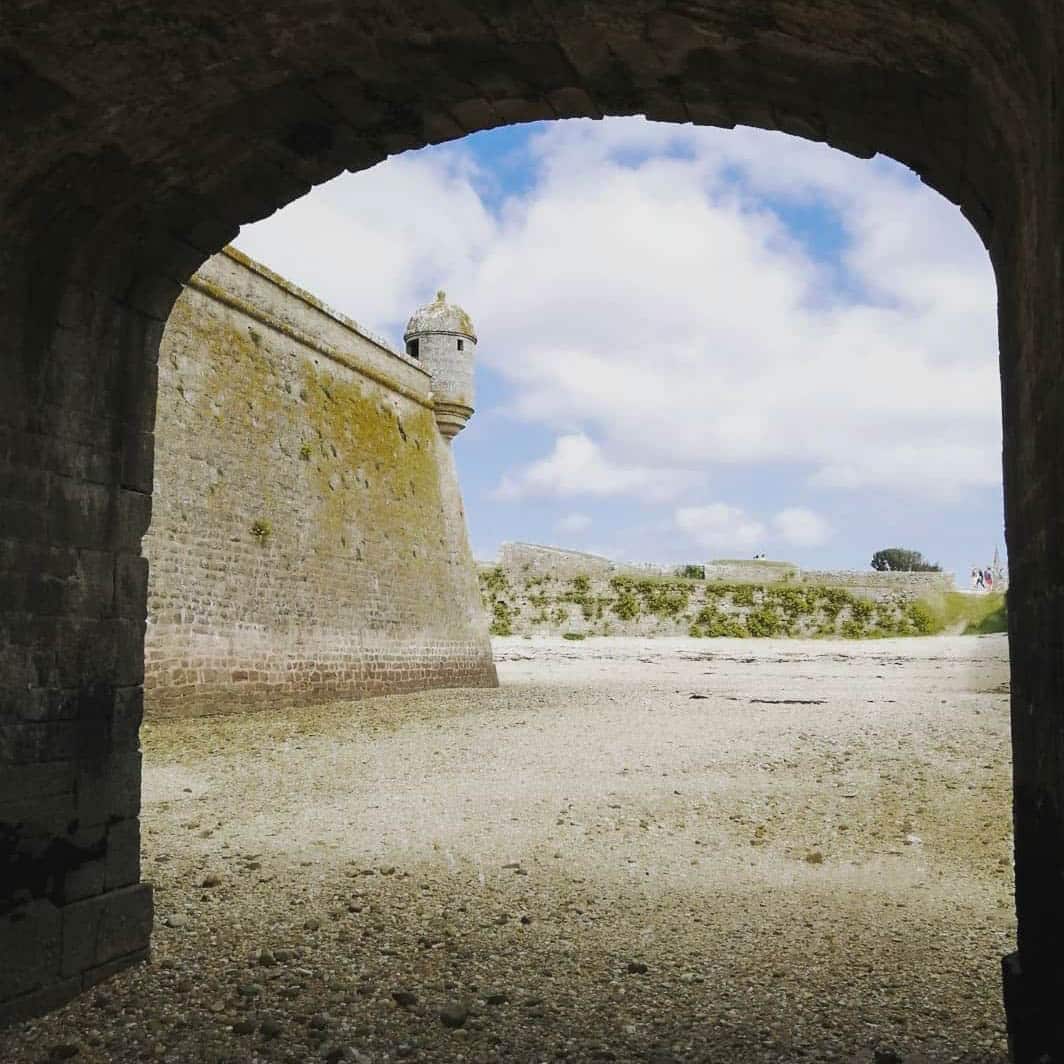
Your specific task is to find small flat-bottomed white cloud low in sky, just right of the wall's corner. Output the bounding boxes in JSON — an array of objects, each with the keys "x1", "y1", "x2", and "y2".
[{"x1": 495, "y1": 432, "x2": 694, "y2": 502}]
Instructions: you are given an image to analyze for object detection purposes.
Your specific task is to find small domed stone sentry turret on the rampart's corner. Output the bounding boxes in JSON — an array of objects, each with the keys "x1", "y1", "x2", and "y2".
[{"x1": 403, "y1": 292, "x2": 477, "y2": 439}]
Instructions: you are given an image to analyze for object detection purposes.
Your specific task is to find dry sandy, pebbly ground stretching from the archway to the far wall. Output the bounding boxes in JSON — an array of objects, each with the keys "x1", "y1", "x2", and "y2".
[{"x1": 0, "y1": 636, "x2": 1014, "y2": 1064}]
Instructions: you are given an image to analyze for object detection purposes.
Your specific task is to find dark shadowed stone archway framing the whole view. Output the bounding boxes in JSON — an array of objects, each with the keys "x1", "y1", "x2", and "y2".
[{"x1": 0, "y1": 0, "x2": 1064, "y2": 1061}]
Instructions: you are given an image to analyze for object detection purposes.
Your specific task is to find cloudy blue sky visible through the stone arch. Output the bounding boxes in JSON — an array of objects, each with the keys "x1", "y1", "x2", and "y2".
[{"x1": 236, "y1": 118, "x2": 1002, "y2": 578}]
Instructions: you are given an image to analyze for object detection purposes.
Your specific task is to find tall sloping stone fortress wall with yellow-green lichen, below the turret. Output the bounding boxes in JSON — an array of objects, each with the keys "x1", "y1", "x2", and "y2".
[{"x1": 144, "y1": 250, "x2": 496, "y2": 714}]
